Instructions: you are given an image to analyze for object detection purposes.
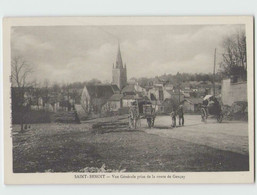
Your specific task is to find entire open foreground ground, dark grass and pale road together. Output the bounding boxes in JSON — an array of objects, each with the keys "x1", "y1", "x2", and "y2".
[{"x1": 12, "y1": 115, "x2": 249, "y2": 173}]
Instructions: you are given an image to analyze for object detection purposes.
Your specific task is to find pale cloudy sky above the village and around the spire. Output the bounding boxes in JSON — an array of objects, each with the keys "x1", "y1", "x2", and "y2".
[{"x1": 11, "y1": 25, "x2": 244, "y2": 83}]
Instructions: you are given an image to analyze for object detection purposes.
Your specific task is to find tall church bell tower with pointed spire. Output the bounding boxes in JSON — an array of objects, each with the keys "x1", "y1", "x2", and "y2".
[{"x1": 112, "y1": 44, "x2": 127, "y2": 90}]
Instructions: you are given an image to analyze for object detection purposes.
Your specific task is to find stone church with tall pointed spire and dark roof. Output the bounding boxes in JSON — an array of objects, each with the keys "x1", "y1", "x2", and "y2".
[{"x1": 81, "y1": 44, "x2": 146, "y2": 115}]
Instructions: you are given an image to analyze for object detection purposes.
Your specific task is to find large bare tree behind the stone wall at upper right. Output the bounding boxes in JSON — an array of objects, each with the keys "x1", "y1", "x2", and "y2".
[{"x1": 220, "y1": 31, "x2": 247, "y2": 80}]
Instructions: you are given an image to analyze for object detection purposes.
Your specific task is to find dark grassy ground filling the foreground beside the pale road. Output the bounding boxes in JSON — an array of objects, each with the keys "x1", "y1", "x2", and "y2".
[{"x1": 13, "y1": 123, "x2": 249, "y2": 173}]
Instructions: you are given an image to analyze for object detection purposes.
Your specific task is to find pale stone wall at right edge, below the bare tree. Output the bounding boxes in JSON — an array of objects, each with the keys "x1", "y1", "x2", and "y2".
[{"x1": 221, "y1": 79, "x2": 247, "y2": 106}]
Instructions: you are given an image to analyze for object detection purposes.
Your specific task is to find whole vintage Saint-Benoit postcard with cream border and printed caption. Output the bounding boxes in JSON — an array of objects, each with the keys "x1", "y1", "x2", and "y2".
[{"x1": 3, "y1": 16, "x2": 254, "y2": 184}]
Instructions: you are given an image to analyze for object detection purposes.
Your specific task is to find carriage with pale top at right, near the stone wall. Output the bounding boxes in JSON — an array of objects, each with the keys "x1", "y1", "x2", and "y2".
[{"x1": 201, "y1": 95, "x2": 223, "y2": 123}]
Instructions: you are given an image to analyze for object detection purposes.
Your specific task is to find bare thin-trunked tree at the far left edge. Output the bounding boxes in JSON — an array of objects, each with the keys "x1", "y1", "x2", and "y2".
[{"x1": 11, "y1": 57, "x2": 32, "y2": 132}]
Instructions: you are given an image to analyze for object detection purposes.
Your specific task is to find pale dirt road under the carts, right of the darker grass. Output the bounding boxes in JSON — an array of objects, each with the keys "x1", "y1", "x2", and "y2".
[{"x1": 141, "y1": 115, "x2": 248, "y2": 155}]
